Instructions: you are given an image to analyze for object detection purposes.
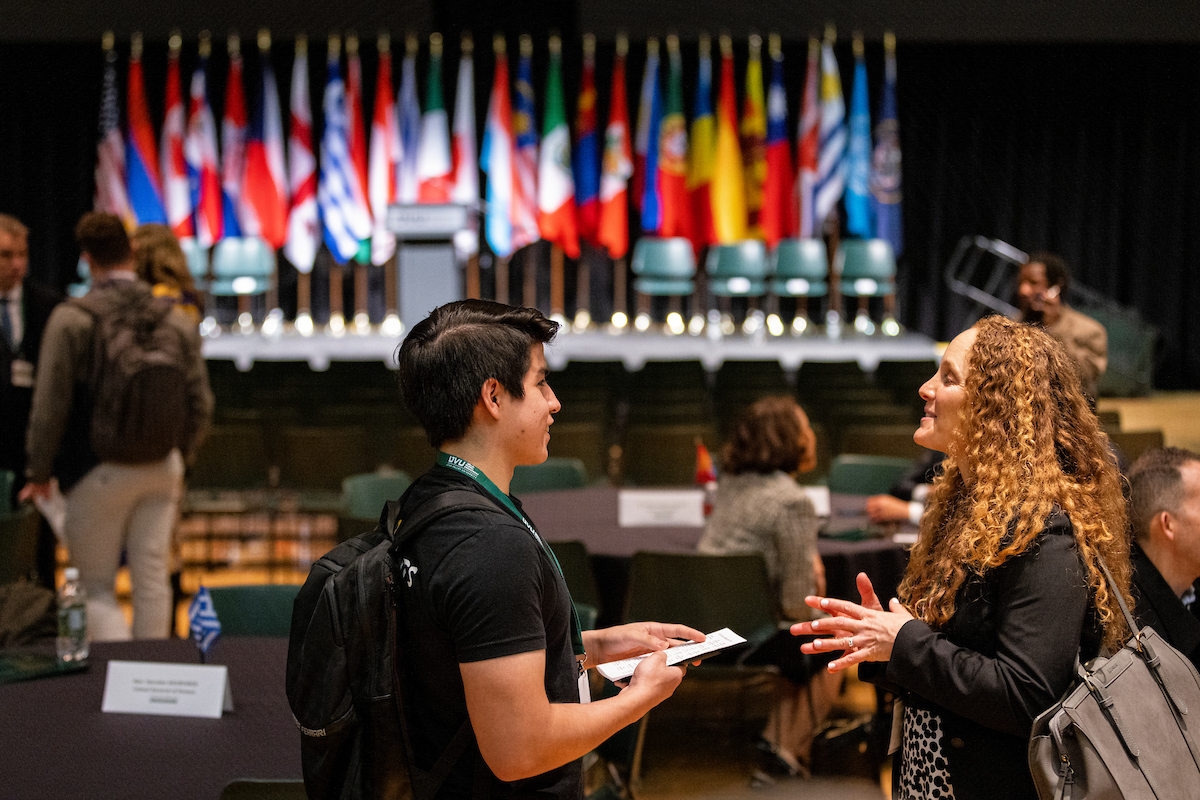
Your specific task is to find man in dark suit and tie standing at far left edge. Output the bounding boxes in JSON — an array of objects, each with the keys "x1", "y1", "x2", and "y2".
[{"x1": 0, "y1": 213, "x2": 62, "y2": 589}]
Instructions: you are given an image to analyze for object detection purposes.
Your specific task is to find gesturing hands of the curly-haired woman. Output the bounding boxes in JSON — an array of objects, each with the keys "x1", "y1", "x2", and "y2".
[{"x1": 792, "y1": 572, "x2": 913, "y2": 672}]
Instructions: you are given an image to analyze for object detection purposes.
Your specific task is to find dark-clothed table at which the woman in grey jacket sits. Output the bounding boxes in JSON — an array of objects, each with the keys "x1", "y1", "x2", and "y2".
[{"x1": 520, "y1": 486, "x2": 916, "y2": 626}]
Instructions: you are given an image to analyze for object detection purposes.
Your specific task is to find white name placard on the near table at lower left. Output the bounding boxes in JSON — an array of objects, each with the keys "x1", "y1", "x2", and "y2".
[{"x1": 100, "y1": 661, "x2": 233, "y2": 720}]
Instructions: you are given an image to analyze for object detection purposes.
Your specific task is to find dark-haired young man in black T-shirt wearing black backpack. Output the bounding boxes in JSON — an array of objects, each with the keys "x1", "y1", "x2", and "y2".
[{"x1": 287, "y1": 300, "x2": 704, "y2": 800}]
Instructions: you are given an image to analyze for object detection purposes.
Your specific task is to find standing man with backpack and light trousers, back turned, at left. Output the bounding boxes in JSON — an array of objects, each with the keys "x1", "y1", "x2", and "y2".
[{"x1": 20, "y1": 212, "x2": 212, "y2": 640}]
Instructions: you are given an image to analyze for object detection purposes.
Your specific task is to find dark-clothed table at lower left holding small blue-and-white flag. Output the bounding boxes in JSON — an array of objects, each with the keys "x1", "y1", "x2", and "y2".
[{"x1": 0, "y1": 637, "x2": 301, "y2": 800}]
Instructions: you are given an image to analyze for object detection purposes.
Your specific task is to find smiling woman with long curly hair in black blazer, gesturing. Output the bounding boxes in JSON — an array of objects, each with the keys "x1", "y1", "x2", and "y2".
[{"x1": 792, "y1": 317, "x2": 1130, "y2": 800}]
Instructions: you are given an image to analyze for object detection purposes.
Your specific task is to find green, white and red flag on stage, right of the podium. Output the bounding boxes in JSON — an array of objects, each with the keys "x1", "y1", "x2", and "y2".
[{"x1": 538, "y1": 36, "x2": 580, "y2": 258}]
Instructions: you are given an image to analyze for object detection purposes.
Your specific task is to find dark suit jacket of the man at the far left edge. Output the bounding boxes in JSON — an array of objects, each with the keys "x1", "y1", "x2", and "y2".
[{"x1": 0, "y1": 278, "x2": 62, "y2": 486}]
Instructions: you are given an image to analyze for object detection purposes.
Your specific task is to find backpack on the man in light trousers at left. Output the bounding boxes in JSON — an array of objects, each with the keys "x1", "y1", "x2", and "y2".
[{"x1": 71, "y1": 290, "x2": 190, "y2": 464}]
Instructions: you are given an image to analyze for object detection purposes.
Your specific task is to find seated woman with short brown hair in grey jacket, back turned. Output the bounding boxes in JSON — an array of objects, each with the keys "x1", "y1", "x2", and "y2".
[{"x1": 698, "y1": 397, "x2": 840, "y2": 775}]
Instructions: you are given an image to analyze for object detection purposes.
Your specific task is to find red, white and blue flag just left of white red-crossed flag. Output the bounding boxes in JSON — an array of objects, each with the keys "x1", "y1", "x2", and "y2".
[{"x1": 241, "y1": 46, "x2": 288, "y2": 249}]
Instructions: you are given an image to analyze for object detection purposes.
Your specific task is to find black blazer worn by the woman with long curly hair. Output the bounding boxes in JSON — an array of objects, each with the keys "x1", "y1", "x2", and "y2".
[{"x1": 859, "y1": 511, "x2": 1100, "y2": 800}]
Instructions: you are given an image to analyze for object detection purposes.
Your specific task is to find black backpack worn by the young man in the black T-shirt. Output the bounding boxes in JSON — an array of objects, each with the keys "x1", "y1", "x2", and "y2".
[{"x1": 287, "y1": 489, "x2": 497, "y2": 800}]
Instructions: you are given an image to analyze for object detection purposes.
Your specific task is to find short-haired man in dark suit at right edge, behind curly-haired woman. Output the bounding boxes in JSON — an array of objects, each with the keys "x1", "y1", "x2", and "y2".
[{"x1": 1129, "y1": 447, "x2": 1200, "y2": 669}]
